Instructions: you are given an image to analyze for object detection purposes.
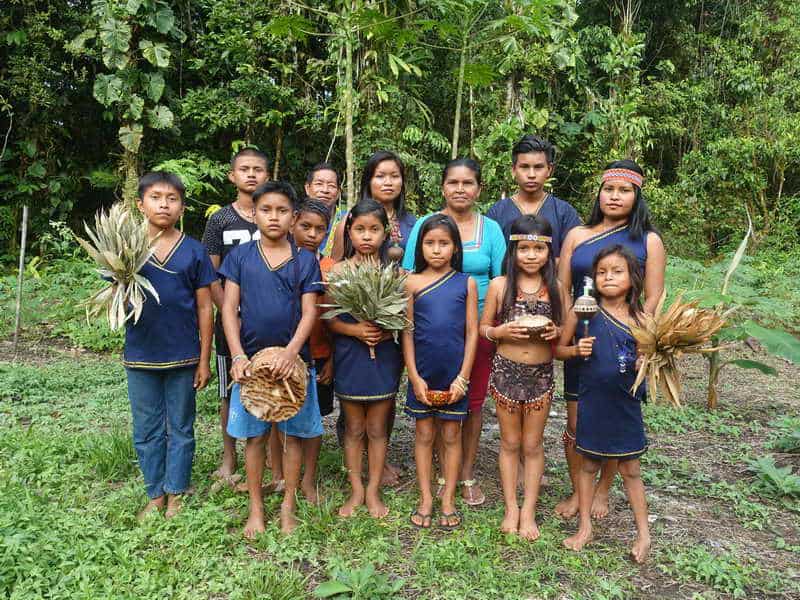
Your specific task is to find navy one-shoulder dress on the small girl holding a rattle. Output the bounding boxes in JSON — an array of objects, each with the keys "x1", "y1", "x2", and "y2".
[{"x1": 575, "y1": 309, "x2": 647, "y2": 460}]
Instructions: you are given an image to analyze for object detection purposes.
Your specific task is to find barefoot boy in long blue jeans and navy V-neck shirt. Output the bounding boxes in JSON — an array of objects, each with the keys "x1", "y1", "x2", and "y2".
[{"x1": 123, "y1": 172, "x2": 217, "y2": 518}]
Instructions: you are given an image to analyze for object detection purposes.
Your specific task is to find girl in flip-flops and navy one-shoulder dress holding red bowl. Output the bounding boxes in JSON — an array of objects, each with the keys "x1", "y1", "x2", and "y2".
[{"x1": 403, "y1": 214, "x2": 478, "y2": 529}]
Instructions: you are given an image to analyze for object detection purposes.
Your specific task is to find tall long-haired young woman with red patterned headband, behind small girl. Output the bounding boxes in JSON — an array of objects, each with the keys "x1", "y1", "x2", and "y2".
[{"x1": 556, "y1": 160, "x2": 667, "y2": 519}]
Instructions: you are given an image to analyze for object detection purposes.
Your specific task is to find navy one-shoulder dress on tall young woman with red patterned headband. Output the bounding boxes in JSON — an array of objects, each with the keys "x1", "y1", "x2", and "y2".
[{"x1": 564, "y1": 224, "x2": 647, "y2": 400}]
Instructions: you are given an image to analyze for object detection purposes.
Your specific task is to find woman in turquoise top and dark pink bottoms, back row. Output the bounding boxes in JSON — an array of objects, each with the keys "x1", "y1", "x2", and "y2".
[{"x1": 403, "y1": 158, "x2": 506, "y2": 506}]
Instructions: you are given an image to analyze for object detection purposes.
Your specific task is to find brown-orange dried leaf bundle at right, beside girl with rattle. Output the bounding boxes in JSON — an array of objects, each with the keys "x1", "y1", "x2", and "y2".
[{"x1": 631, "y1": 295, "x2": 727, "y2": 407}]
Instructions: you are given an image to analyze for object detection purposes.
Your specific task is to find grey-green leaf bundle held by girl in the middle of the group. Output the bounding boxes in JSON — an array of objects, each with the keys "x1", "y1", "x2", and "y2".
[{"x1": 322, "y1": 261, "x2": 411, "y2": 358}]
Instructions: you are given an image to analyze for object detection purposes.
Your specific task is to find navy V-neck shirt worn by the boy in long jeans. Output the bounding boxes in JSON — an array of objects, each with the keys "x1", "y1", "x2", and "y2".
[{"x1": 122, "y1": 234, "x2": 217, "y2": 369}]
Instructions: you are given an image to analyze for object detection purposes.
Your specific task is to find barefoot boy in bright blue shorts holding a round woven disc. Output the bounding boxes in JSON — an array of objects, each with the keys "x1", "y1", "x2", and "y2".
[{"x1": 220, "y1": 181, "x2": 322, "y2": 538}]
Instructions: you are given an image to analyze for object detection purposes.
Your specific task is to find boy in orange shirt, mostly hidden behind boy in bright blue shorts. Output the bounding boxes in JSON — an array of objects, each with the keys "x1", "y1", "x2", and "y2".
[{"x1": 292, "y1": 198, "x2": 334, "y2": 504}]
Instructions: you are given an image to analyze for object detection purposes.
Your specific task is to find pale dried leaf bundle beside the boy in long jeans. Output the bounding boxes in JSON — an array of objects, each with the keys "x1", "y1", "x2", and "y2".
[{"x1": 75, "y1": 202, "x2": 160, "y2": 331}]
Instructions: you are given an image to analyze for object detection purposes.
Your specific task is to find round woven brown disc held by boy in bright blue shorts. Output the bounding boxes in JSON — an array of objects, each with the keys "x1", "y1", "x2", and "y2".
[{"x1": 241, "y1": 346, "x2": 308, "y2": 423}]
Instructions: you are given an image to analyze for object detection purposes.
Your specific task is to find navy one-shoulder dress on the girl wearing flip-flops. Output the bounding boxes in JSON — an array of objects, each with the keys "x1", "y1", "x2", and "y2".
[{"x1": 406, "y1": 271, "x2": 469, "y2": 421}]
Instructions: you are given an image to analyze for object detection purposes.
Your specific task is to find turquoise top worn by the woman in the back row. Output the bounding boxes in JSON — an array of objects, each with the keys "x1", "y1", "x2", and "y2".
[{"x1": 403, "y1": 213, "x2": 506, "y2": 313}]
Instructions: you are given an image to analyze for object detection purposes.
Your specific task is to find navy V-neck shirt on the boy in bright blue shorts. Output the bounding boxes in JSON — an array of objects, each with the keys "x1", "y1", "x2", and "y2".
[{"x1": 219, "y1": 241, "x2": 323, "y2": 362}]
